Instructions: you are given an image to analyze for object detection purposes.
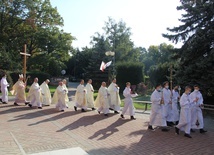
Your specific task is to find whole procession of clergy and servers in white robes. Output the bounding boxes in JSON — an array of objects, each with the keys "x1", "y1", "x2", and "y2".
[{"x1": 1, "y1": 74, "x2": 207, "y2": 138}]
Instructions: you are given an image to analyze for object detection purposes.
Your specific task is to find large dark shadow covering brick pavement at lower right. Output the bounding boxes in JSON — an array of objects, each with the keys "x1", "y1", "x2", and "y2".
[{"x1": 87, "y1": 130, "x2": 214, "y2": 155}]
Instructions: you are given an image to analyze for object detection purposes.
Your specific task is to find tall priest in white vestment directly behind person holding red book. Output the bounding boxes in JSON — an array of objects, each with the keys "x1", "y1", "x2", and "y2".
[{"x1": 108, "y1": 79, "x2": 121, "y2": 114}]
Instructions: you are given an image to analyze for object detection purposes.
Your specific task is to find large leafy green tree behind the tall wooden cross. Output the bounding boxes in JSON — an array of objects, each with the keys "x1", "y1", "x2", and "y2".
[{"x1": 0, "y1": 0, "x2": 75, "y2": 75}]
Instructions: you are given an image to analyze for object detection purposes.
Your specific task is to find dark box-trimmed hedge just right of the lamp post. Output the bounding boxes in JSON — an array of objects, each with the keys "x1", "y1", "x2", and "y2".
[{"x1": 117, "y1": 62, "x2": 144, "y2": 90}]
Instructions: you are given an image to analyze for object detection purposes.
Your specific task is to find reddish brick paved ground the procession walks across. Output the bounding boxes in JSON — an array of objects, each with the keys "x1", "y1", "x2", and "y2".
[{"x1": 0, "y1": 83, "x2": 214, "y2": 155}]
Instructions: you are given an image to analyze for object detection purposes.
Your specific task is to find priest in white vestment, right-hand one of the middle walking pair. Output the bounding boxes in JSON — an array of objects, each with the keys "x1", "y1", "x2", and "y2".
[{"x1": 85, "y1": 79, "x2": 95, "y2": 110}]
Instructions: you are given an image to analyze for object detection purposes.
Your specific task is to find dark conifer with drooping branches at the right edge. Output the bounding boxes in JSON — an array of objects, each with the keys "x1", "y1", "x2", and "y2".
[{"x1": 163, "y1": 0, "x2": 214, "y2": 99}]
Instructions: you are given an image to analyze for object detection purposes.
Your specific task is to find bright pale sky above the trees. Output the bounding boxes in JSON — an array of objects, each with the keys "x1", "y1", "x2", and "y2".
[{"x1": 50, "y1": 0, "x2": 182, "y2": 48}]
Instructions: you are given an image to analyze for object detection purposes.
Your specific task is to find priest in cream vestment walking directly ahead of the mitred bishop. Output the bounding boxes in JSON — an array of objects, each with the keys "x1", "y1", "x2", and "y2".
[{"x1": 28, "y1": 78, "x2": 42, "y2": 109}]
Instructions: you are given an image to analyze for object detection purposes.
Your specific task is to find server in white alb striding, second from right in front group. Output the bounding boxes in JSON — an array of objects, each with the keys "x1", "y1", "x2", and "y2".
[{"x1": 175, "y1": 86, "x2": 198, "y2": 138}]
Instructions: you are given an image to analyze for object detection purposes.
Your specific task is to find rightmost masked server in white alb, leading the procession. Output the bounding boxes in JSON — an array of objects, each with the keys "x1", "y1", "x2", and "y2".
[{"x1": 190, "y1": 85, "x2": 207, "y2": 133}]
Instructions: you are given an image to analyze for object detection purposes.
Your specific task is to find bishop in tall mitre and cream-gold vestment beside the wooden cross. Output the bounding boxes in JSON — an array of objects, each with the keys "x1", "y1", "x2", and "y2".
[{"x1": 11, "y1": 74, "x2": 29, "y2": 106}]
